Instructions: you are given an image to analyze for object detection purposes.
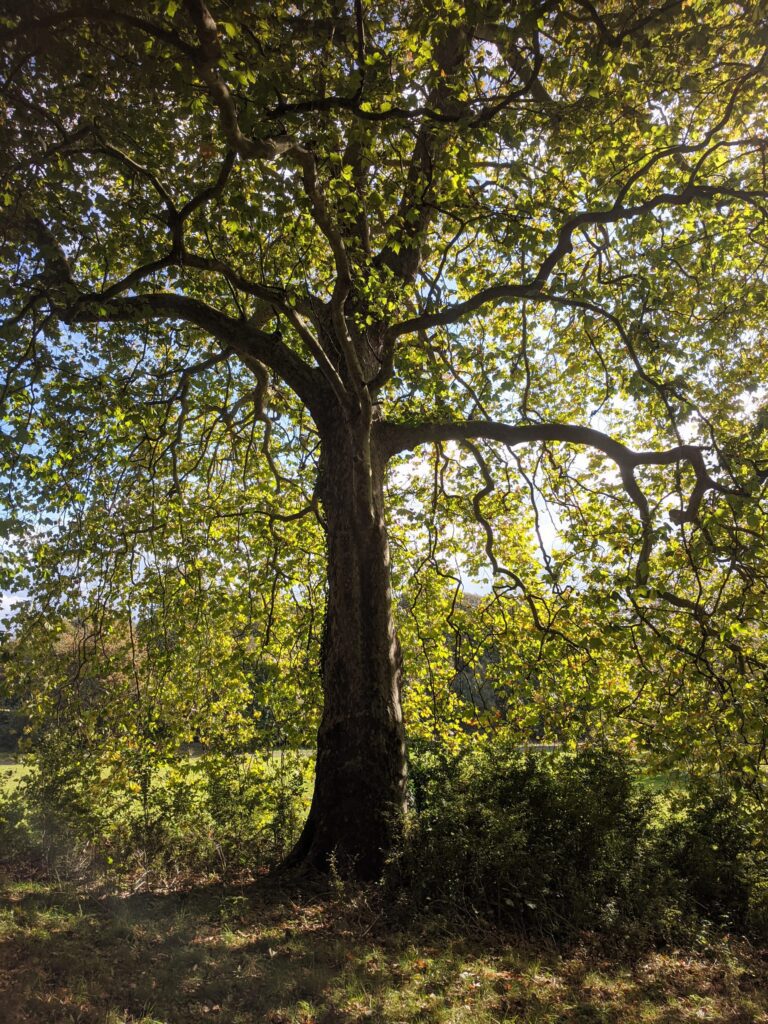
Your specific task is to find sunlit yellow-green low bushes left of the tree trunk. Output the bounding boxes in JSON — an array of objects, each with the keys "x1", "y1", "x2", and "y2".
[{"x1": 0, "y1": 753, "x2": 309, "y2": 887}]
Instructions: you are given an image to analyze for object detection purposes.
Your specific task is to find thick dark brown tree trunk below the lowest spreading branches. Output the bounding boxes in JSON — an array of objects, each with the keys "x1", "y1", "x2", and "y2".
[{"x1": 289, "y1": 417, "x2": 406, "y2": 880}]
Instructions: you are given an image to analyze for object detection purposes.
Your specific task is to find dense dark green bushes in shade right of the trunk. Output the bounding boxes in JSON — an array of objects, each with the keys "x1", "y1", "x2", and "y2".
[{"x1": 390, "y1": 743, "x2": 768, "y2": 945}]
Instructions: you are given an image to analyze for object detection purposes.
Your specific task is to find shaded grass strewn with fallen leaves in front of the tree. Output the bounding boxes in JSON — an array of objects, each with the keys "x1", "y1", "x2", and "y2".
[{"x1": 0, "y1": 879, "x2": 768, "y2": 1024}]
